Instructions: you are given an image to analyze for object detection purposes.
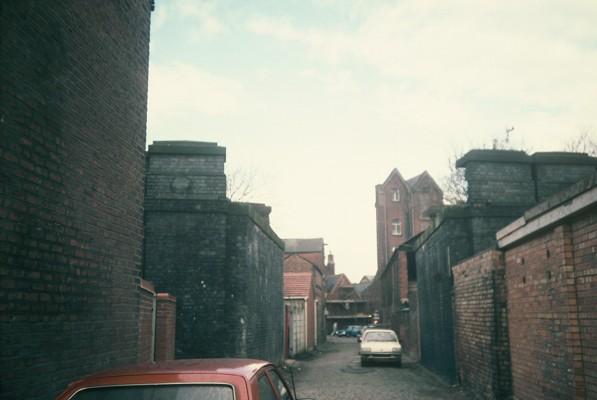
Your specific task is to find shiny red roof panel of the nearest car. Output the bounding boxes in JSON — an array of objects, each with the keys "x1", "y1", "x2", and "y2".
[{"x1": 82, "y1": 358, "x2": 272, "y2": 380}]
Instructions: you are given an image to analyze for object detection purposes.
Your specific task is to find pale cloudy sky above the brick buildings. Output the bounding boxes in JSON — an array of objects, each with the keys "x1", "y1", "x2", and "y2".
[{"x1": 147, "y1": 0, "x2": 597, "y2": 282}]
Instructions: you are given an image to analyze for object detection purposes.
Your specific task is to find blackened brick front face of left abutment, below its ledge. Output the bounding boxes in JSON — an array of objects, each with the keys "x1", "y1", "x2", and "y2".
[{"x1": 144, "y1": 209, "x2": 229, "y2": 358}]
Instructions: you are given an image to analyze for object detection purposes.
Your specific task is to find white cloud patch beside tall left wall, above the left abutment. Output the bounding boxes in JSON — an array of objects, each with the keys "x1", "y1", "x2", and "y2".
[{"x1": 148, "y1": 63, "x2": 244, "y2": 119}]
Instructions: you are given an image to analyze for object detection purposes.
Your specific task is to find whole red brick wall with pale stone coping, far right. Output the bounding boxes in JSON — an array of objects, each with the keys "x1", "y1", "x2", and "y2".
[{"x1": 497, "y1": 175, "x2": 597, "y2": 399}]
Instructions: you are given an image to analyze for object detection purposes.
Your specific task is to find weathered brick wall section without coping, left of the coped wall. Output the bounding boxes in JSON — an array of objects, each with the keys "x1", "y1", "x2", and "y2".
[{"x1": 452, "y1": 250, "x2": 512, "y2": 399}]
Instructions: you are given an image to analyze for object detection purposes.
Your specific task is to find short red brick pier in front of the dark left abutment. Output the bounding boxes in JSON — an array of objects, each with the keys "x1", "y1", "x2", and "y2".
[{"x1": 155, "y1": 293, "x2": 176, "y2": 361}]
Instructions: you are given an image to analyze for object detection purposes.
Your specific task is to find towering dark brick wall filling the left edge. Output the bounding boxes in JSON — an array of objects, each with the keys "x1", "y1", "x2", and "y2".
[{"x1": 0, "y1": 0, "x2": 150, "y2": 399}]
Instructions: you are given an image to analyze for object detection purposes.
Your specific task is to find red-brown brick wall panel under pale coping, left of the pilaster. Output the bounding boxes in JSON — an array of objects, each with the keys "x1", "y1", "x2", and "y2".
[{"x1": 506, "y1": 227, "x2": 584, "y2": 400}]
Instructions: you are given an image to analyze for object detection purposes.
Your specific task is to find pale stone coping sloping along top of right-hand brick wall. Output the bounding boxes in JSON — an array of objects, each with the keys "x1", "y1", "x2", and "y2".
[{"x1": 496, "y1": 174, "x2": 597, "y2": 248}]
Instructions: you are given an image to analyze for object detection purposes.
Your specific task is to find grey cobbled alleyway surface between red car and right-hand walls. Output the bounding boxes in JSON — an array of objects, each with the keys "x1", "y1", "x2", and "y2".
[{"x1": 295, "y1": 337, "x2": 468, "y2": 400}]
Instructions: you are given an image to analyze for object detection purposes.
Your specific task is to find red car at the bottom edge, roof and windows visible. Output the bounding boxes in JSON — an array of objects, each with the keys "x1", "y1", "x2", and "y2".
[{"x1": 57, "y1": 358, "x2": 302, "y2": 400}]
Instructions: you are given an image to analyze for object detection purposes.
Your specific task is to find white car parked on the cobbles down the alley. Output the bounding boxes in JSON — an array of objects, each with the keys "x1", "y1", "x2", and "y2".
[{"x1": 359, "y1": 328, "x2": 402, "y2": 367}]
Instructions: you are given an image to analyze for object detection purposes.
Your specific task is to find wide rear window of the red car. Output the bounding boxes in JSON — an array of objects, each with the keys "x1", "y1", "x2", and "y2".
[{"x1": 72, "y1": 385, "x2": 234, "y2": 400}]
